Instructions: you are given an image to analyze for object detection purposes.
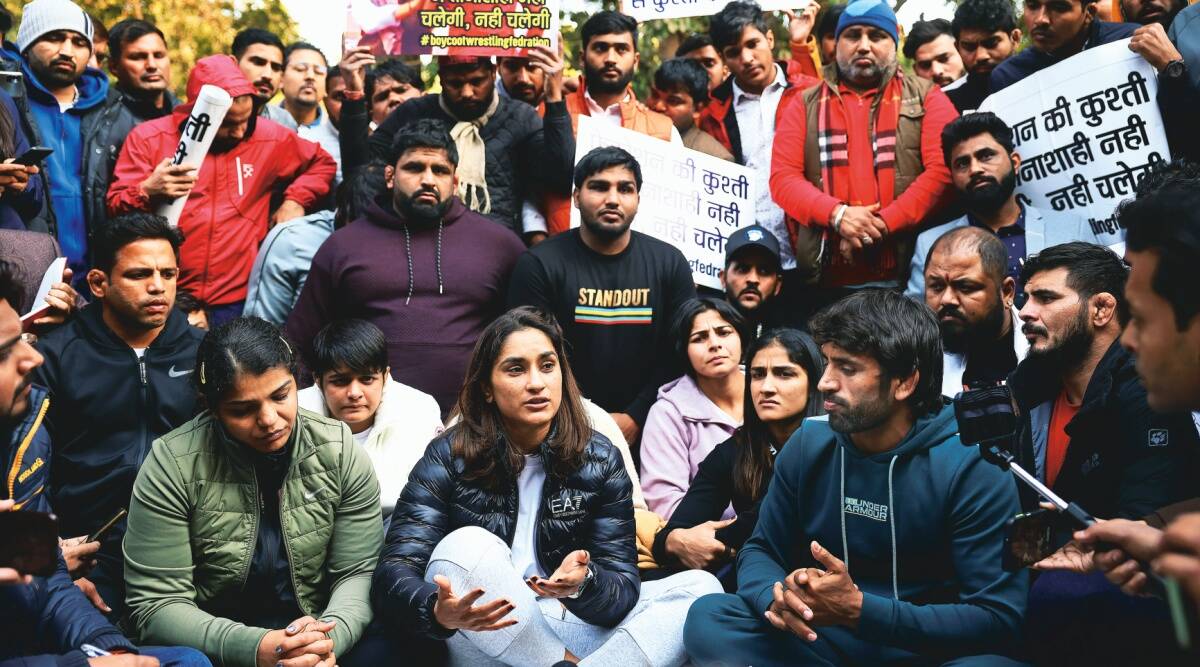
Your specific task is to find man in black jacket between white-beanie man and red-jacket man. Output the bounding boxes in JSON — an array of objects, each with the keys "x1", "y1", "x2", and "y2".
[{"x1": 83, "y1": 18, "x2": 179, "y2": 229}]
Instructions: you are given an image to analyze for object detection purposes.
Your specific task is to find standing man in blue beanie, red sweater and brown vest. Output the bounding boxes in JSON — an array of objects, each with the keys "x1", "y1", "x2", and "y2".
[{"x1": 770, "y1": 0, "x2": 958, "y2": 306}]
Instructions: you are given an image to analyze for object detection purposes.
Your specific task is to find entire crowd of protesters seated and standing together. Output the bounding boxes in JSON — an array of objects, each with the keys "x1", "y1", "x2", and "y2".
[{"x1": 0, "y1": 0, "x2": 1200, "y2": 667}]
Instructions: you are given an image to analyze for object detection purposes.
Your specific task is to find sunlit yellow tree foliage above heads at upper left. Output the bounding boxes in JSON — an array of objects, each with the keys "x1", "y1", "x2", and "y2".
[{"x1": 6, "y1": 0, "x2": 297, "y2": 97}]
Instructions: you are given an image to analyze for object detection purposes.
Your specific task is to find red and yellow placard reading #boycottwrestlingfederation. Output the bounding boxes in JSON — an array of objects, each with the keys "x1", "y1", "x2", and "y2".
[{"x1": 343, "y1": 0, "x2": 560, "y2": 56}]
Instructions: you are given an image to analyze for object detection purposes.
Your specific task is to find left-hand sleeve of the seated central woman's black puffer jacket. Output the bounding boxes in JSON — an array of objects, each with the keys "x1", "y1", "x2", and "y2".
[{"x1": 371, "y1": 435, "x2": 456, "y2": 639}]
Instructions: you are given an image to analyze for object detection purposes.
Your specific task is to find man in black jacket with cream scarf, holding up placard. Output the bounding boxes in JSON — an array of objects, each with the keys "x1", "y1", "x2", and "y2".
[{"x1": 370, "y1": 56, "x2": 575, "y2": 235}]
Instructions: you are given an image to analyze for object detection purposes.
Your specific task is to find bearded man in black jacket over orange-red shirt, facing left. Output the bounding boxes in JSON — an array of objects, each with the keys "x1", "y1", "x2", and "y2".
[{"x1": 1009, "y1": 242, "x2": 1196, "y2": 518}]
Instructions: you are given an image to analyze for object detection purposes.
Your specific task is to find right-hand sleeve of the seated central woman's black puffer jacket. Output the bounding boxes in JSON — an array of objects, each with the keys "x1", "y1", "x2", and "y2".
[{"x1": 559, "y1": 435, "x2": 642, "y2": 627}]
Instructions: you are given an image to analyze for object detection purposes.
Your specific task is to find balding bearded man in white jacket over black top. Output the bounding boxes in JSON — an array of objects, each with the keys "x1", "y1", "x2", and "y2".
[{"x1": 925, "y1": 227, "x2": 1030, "y2": 397}]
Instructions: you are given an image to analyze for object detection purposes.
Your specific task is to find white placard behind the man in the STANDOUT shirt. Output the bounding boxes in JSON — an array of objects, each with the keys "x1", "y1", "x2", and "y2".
[{"x1": 571, "y1": 115, "x2": 755, "y2": 289}]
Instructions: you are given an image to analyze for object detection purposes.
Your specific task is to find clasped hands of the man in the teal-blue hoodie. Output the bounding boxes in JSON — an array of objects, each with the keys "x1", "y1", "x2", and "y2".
[{"x1": 766, "y1": 541, "x2": 863, "y2": 642}]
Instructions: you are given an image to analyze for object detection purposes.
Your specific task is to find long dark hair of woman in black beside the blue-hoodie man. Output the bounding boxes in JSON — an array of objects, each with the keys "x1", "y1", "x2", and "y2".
[{"x1": 733, "y1": 329, "x2": 824, "y2": 498}]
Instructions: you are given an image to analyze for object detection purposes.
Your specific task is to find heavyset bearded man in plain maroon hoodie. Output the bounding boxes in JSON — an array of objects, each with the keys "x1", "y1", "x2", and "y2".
[{"x1": 284, "y1": 120, "x2": 524, "y2": 415}]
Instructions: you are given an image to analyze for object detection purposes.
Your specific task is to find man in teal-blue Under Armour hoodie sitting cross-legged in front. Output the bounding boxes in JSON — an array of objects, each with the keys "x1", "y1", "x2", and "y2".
[{"x1": 684, "y1": 290, "x2": 1028, "y2": 667}]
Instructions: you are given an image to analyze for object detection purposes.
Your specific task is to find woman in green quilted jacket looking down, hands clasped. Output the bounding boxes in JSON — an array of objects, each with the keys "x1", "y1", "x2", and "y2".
[{"x1": 125, "y1": 318, "x2": 446, "y2": 667}]
